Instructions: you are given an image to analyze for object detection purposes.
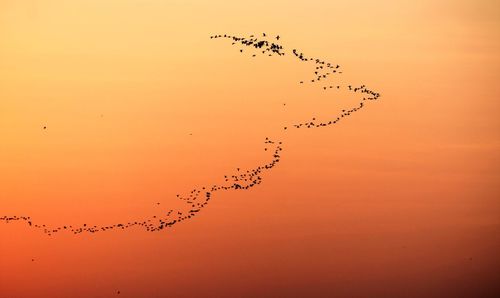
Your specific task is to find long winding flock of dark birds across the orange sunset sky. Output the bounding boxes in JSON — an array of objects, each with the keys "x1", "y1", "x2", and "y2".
[{"x1": 0, "y1": 33, "x2": 380, "y2": 236}]
